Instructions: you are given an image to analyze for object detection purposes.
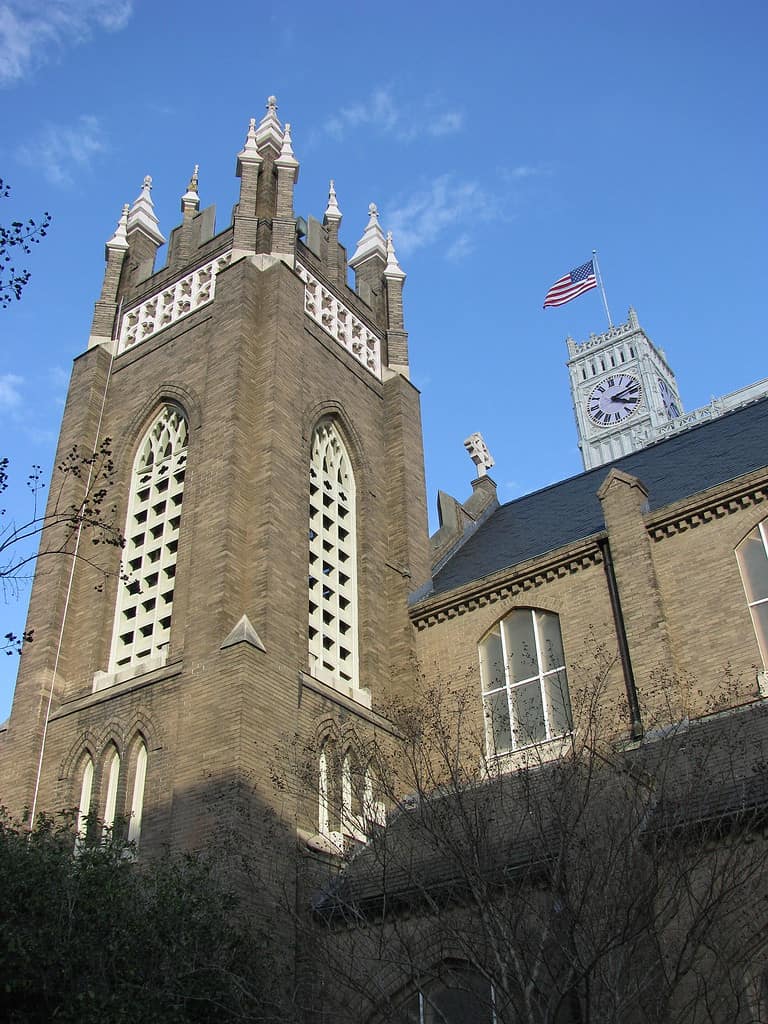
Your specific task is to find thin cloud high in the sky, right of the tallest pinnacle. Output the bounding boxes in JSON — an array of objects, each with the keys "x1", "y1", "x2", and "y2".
[{"x1": 324, "y1": 87, "x2": 464, "y2": 142}]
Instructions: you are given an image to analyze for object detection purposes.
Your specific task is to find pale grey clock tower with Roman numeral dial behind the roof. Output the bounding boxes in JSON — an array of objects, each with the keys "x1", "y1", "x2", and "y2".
[{"x1": 566, "y1": 308, "x2": 683, "y2": 469}]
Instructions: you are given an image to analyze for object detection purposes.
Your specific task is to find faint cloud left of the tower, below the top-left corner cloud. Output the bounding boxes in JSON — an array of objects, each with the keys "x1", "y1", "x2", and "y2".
[{"x1": 16, "y1": 114, "x2": 106, "y2": 185}]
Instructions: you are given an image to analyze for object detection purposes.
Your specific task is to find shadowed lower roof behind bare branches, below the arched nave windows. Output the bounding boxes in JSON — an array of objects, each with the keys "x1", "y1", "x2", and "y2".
[{"x1": 313, "y1": 700, "x2": 768, "y2": 921}]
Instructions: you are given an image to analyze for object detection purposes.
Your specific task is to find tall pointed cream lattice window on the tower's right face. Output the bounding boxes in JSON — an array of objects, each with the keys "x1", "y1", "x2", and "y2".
[{"x1": 309, "y1": 421, "x2": 357, "y2": 687}]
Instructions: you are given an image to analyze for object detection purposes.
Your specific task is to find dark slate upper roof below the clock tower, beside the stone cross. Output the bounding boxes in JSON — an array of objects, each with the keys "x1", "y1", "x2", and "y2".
[{"x1": 431, "y1": 398, "x2": 768, "y2": 594}]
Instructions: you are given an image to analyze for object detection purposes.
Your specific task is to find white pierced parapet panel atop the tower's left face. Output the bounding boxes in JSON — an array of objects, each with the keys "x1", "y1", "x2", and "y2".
[{"x1": 118, "y1": 253, "x2": 232, "y2": 352}]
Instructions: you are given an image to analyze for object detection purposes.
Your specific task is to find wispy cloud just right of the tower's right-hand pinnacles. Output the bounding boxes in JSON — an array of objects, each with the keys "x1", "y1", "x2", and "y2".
[{"x1": 382, "y1": 174, "x2": 498, "y2": 260}]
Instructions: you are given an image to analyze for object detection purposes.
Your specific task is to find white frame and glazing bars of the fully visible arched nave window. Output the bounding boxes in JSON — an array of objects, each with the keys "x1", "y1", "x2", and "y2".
[{"x1": 479, "y1": 608, "x2": 572, "y2": 757}]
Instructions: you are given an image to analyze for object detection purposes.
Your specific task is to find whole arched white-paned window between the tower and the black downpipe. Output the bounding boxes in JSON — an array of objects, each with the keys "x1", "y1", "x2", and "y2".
[{"x1": 480, "y1": 608, "x2": 571, "y2": 755}]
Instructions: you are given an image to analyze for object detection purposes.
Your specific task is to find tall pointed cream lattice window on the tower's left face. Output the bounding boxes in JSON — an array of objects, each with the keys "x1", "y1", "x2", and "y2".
[{"x1": 111, "y1": 406, "x2": 187, "y2": 672}]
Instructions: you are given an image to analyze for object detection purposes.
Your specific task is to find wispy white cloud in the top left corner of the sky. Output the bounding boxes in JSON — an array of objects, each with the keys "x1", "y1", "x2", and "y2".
[{"x1": 0, "y1": 0, "x2": 133, "y2": 85}]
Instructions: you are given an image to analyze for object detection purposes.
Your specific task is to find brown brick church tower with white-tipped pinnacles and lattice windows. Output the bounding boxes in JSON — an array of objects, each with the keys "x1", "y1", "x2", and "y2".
[{"x1": 0, "y1": 97, "x2": 429, "y2": 868}]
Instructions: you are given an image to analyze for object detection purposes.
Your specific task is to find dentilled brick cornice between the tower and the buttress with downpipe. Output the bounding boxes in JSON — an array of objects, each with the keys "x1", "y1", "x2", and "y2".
[{"x1": 410, "y1": 534, "x2": 604, "y2": 630}]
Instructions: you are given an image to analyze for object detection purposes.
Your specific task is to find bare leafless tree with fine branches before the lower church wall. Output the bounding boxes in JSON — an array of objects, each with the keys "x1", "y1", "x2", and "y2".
[{"x1": 286, "y1": 668, "x2": 768, "y2": 1024}]
